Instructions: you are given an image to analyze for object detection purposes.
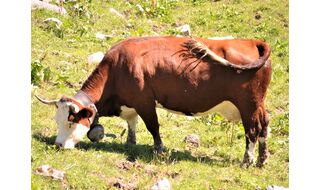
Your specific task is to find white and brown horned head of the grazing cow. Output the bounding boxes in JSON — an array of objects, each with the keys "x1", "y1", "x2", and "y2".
[{"x1": 36, "y1": 96, "x2": 96, "y2": 149}]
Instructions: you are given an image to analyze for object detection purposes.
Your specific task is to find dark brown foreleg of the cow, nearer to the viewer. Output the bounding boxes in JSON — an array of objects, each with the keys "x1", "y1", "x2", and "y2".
[{"x1": 137, "y1": 107, "x2": 164, "y2": 153}]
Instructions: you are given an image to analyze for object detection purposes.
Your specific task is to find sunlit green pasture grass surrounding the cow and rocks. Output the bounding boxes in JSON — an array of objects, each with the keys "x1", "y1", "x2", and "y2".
[{"x1": 31, "y1": 0, "x2": 289, "y2": 189}]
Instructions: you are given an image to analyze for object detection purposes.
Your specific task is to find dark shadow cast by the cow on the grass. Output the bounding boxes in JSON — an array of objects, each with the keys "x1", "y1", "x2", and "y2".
[{"x1": 33, "y1": 133, "x2": 240, "y2": 167}]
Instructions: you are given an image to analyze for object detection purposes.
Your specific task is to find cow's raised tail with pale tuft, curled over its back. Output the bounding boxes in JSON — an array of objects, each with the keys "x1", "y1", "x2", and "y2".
[{"x1": 184, "y1": 40, "x2": 270, "y2": 71}]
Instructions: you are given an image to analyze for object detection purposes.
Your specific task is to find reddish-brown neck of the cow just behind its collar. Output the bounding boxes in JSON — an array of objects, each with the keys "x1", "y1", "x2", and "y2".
[{"x1": 81, "y1": 61, "x2": 109, "y2": 104}]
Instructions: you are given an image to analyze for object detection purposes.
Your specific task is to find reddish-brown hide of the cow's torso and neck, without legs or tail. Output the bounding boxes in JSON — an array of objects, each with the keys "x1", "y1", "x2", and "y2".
[{"x1": 82, "y1": 37, "x2": 271, "y2": 115}]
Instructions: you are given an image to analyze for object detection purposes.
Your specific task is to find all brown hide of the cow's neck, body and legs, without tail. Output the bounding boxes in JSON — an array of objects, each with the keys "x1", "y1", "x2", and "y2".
[{"x1": 81, "y1": 36, "x2": 271, "y2": 166}]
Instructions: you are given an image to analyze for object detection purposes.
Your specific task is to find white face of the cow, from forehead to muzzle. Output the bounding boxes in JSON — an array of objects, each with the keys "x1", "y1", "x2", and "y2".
[{"x1": 55, "y1": 102, "x2": 89, "y2": 149}]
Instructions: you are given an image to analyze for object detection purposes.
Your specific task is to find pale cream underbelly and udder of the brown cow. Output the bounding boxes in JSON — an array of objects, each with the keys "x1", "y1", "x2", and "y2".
[{"x1": 156, "y1": 101, "x2": 241, "y2": 122}]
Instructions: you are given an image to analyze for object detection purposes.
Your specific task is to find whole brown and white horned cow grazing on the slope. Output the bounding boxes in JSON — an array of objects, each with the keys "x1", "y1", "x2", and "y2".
[{"x1": 37, "y1": 36, "x2": 272, "y2": 167}]
